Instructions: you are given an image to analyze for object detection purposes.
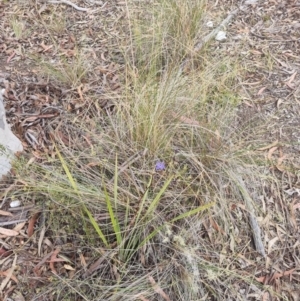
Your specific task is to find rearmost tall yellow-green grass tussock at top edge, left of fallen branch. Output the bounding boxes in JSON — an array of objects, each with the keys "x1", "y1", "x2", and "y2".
[{"x1": 130, "y1": 0, "x2": 205, "y2": 72}]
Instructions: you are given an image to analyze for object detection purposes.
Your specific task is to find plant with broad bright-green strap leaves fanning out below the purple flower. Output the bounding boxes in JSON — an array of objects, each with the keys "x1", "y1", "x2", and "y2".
[{"x1": 57, "y1": 150, "x2": 213, "y2": 262}]
